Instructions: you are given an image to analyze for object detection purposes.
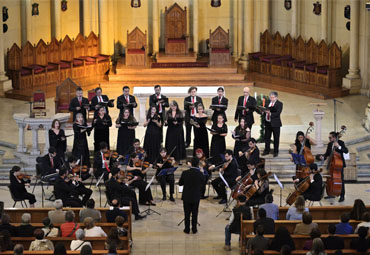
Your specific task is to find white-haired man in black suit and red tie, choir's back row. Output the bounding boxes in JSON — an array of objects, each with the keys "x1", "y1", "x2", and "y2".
[{"x1": 234, "y1": 87, "x2": 257, "y2": 129}]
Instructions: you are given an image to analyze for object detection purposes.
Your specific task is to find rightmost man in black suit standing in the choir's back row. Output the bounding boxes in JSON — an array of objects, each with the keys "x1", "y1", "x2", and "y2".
[{"x1": 262, "y1": 91, "x2": 283, "y2": 157}]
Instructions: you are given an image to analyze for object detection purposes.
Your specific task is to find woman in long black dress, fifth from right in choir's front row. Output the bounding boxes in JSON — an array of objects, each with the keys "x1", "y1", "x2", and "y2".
[{"x1": 144, "y1": 106, "x2": 162, "y2": 164}]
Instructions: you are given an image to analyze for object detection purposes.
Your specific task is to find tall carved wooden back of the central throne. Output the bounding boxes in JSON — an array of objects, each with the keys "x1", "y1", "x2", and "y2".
[{"x1": 165, "y1": 3, "x2": 187, "y2": 39}]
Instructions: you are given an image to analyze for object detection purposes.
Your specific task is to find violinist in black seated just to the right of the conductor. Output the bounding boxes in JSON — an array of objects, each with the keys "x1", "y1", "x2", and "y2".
[{"x1": 212, "y1": 150, "x2": 238, "y2": 204}]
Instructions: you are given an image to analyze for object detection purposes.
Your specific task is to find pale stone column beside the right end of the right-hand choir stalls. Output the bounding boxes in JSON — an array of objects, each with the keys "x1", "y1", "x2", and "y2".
[{"x1": 343, "y1": 0, "x2": 362, "y2": 94}]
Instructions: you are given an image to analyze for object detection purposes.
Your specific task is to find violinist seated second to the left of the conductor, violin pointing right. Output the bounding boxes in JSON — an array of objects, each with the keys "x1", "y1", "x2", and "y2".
[{"x1": 126, "y1": 153, "x2": 155, "y2": 205}]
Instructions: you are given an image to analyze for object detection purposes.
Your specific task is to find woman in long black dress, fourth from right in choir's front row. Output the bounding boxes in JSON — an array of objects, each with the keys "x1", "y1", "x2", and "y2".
[{"x1": 166, "y1": 101, "x2": 186, "y2": 163}]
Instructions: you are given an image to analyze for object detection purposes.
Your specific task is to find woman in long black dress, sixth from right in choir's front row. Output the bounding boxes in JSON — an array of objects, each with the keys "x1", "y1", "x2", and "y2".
[{"x1": 116, "y1": 108, "x2": 136, "y2": 156}]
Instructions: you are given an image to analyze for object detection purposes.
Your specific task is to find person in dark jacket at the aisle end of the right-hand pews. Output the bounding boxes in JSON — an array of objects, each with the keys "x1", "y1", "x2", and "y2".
[{"x1": 224, "y1": 196, "x2": 252, "y2": 251}]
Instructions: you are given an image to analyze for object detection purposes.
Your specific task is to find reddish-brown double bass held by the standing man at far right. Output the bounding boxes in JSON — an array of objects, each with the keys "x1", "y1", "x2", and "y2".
[{"x1": 326, "y1": 126, "x2": 347, "y2": 196}]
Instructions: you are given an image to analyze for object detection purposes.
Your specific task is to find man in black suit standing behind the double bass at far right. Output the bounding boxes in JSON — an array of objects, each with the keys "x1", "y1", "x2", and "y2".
[{"x1": 320, "y1": 131, "x2": 348, "y2": 202}]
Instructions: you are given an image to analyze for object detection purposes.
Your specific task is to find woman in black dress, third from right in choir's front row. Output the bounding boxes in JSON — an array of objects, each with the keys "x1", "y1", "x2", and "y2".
[{"x1": 193, "y1": 104, "x2": 209, "y2": 158}]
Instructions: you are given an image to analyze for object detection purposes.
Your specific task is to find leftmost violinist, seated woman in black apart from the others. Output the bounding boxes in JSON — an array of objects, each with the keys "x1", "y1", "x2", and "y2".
[{"x1": 9, "y1": 166, "x2": 36, "y2": 208}]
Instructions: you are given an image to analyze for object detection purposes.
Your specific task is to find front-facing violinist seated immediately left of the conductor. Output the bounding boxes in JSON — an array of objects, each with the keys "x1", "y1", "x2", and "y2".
[{"x1": 155, "y1": 148, "x2": 175, "y2": 202}]
